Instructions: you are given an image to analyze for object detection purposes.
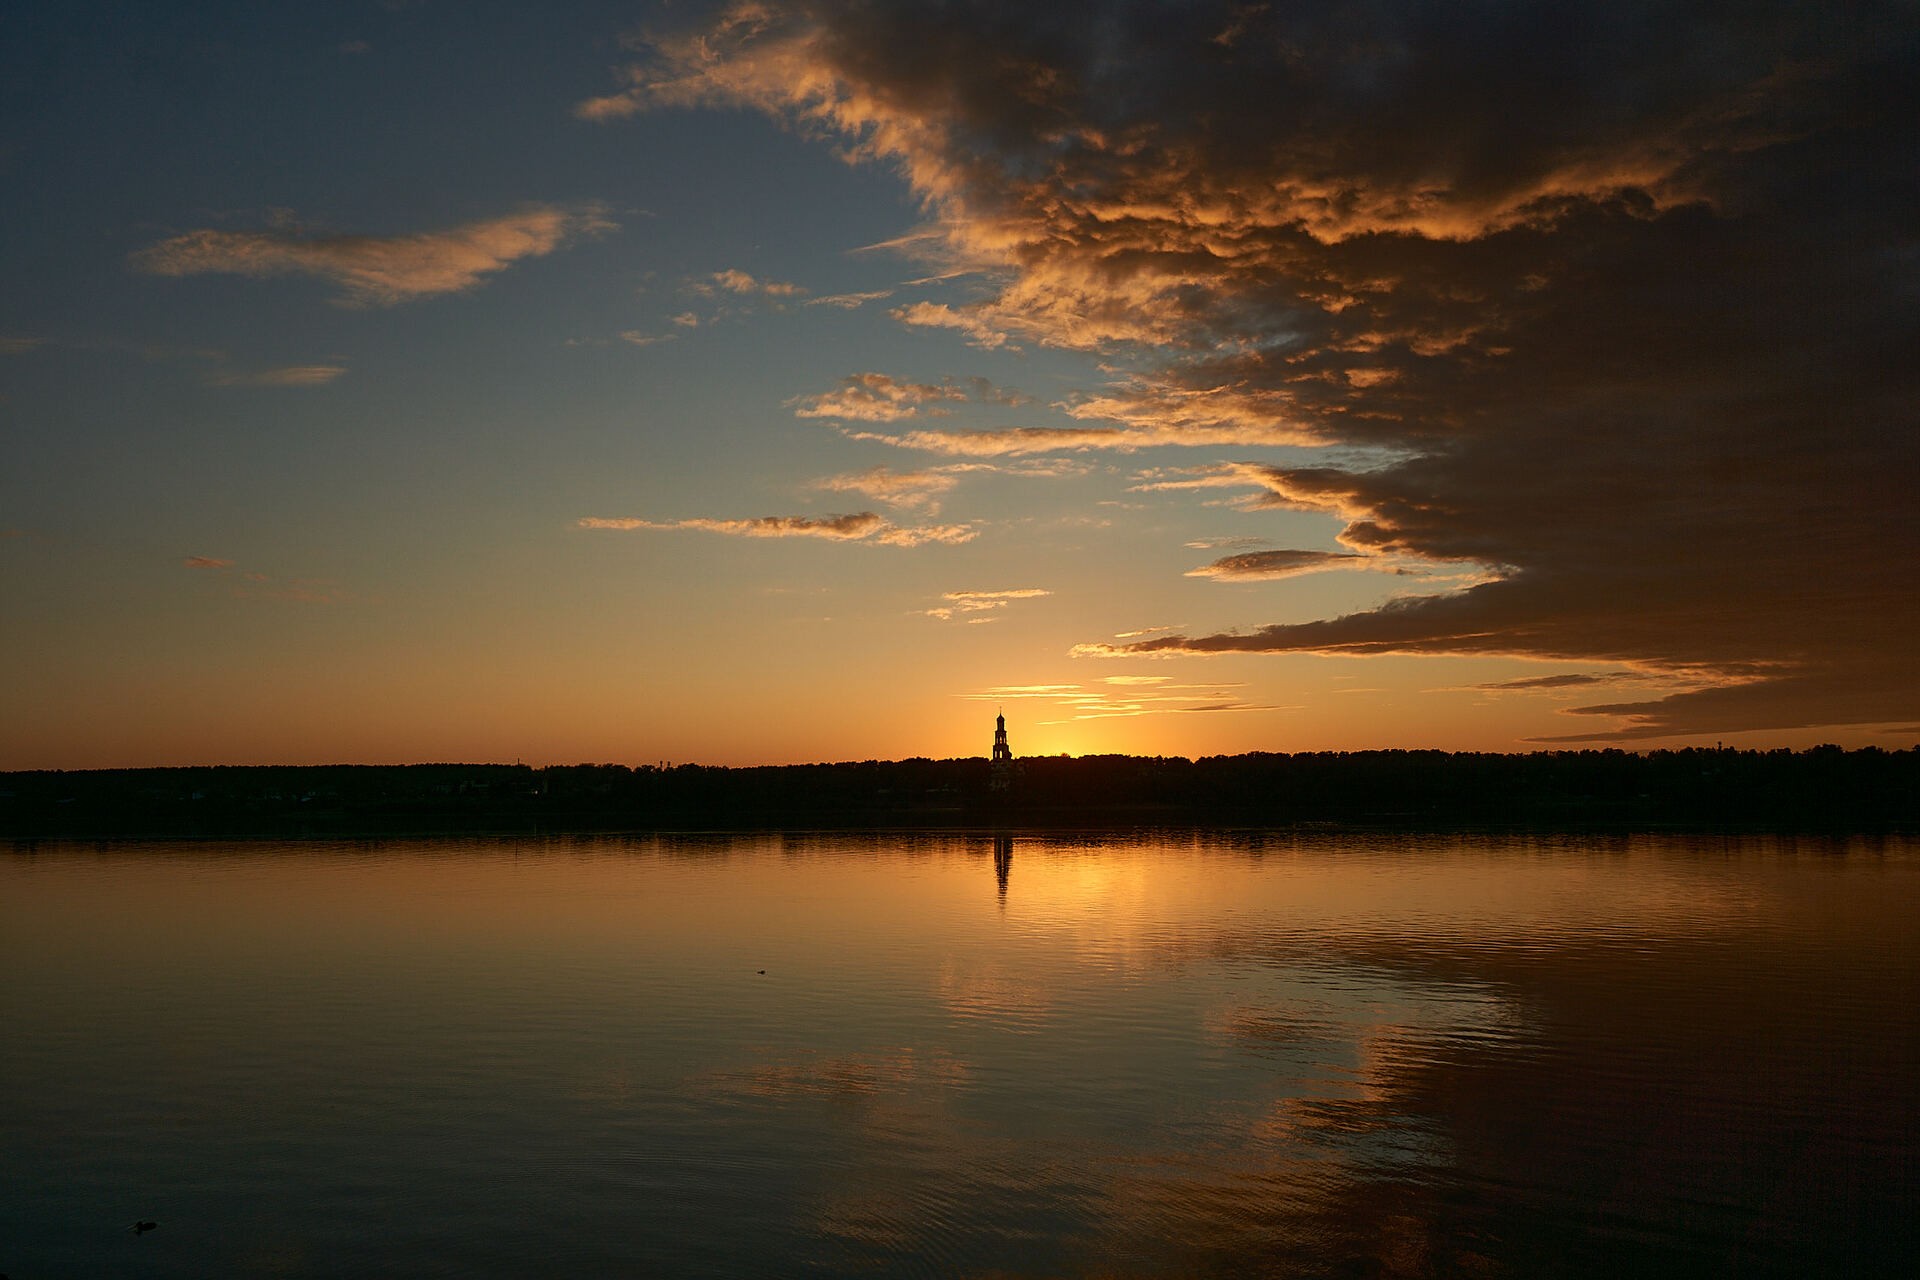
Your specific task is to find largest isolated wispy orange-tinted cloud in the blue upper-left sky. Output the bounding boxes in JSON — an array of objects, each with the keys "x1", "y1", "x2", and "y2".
[{"x1": 131, "y1": 205, "x2": 614, "y2": 307}]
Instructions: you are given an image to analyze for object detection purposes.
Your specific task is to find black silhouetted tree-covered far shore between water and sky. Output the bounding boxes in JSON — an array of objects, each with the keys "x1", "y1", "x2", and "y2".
[{"x1": 0, "y1": 747, "x2": 1920, "y2": 841}]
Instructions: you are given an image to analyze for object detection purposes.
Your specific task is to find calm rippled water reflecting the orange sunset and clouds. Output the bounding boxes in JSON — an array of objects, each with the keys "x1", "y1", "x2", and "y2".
[{"x1": 0, "y1": 833, "x2": 1920, "y2": 1280}]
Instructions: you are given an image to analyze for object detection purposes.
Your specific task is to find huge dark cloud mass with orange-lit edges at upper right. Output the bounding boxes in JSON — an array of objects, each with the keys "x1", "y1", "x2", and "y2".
[{"x1": 582, "y1": 0, "x2": 1920, "y2": 739}]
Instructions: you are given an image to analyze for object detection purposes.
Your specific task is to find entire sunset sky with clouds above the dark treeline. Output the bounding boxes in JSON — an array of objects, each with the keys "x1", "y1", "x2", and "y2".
[{"x1": 0, "y1": 0, "x2": 1920, "y2": 770}]
